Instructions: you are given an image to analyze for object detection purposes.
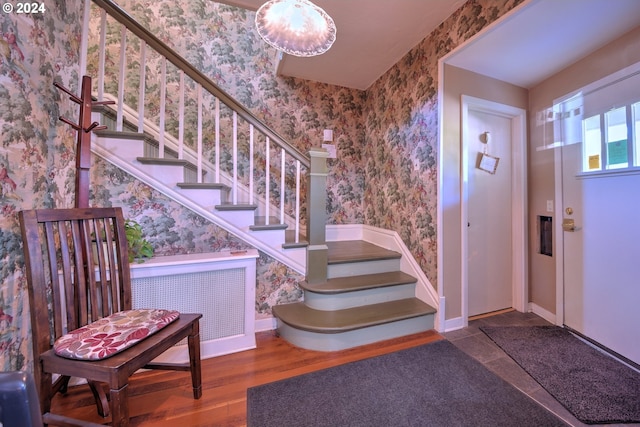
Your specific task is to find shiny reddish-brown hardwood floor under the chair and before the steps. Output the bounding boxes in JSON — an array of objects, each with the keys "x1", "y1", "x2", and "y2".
[{"x1": 53, "y1": 331, "x2": 443, "y2": 427}]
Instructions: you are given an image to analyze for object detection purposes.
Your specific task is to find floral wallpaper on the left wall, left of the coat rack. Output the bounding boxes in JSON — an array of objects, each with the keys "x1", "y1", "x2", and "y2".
[{"x1": 0, "y1": 0, "x2": 82, "y2": 370}]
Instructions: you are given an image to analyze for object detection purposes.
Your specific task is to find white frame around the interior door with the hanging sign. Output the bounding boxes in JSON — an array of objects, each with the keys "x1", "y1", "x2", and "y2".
[{"x1": 460, "y1": 95, "x2": 529, "y2": 326}]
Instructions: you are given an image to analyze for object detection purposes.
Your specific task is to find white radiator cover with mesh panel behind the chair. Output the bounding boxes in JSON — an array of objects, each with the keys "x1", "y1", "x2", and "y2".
[{"x1": 131, "y1": 249, "x2": 258, "y2": 363}]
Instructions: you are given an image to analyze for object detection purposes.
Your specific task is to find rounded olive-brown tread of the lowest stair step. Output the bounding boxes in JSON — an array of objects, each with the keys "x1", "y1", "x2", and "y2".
[{"x1": 273, "y1": 298, "x2": 436, "y2": 334}]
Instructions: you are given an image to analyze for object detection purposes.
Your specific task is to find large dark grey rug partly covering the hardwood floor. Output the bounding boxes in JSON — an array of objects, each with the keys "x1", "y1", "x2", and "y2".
[{"x1": 247, "y1": 340, "x2": 566, "y2": 427}]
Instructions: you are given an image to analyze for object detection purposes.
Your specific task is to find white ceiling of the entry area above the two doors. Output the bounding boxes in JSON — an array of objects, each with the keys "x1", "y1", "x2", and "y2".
[{"x1": 446, "y1": 0, "x2": 640, "y2": 88}]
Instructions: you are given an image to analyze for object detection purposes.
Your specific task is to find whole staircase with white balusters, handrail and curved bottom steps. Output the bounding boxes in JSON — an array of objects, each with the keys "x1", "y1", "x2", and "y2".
[{"x1": 86, "y1": 0, "x2": 437, "y2": 351}]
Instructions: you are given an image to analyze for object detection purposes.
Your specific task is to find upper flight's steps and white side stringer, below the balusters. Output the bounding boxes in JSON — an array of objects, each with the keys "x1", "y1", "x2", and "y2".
[{"x1": 92, "y1": 102, "x2": 307, "y2": 274}]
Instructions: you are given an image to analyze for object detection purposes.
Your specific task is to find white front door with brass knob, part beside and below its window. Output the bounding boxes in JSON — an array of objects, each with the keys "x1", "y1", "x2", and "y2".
[{"x1": 562, "y1": 144, "x2": 640, "y2": 363}]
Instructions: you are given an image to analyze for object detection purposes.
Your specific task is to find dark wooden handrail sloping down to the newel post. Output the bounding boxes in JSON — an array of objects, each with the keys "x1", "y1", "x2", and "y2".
[{"x1": 93, "y1": 0, "x2": 310, "y2": 168}]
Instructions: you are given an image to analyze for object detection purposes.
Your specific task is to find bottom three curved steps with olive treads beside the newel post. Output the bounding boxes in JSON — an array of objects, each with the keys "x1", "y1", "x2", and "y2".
[{"x1": 273, "y1": 240, "x2": 436, "y2": 351}]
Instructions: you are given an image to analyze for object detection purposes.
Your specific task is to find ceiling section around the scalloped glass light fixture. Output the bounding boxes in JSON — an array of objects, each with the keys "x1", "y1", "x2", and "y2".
[{"x1": 216, "y1": 0, "x2": 466, "y2": 90}]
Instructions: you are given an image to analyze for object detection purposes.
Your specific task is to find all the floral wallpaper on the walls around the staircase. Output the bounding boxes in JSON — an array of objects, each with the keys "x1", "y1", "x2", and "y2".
[{"x1": 0, "y1": 0, "x2": 520, "y2": 370}]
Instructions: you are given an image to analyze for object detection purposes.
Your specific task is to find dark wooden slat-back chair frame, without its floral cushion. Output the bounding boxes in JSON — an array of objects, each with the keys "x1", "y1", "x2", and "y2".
[{"x1": 19, "y1": 207, "x2": 202, "y2": 426}]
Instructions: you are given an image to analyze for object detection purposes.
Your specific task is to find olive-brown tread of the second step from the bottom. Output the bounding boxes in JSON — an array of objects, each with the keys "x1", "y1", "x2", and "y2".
[{"x1": 300, "y1": 271, "x2": 417, "y2": 294}]
